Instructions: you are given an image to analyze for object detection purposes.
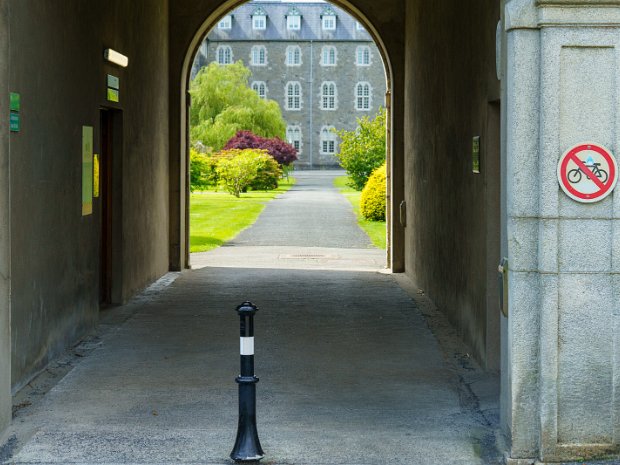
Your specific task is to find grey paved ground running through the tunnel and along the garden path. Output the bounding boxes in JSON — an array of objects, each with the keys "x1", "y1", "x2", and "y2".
[{"x1": 0, "y1": 172, "x2": 499, "y2": 465}]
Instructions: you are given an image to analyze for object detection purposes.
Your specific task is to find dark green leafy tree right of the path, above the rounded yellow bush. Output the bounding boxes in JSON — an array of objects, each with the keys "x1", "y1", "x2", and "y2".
[{"x1": 337, "y1": 108, "x2": 386, "y2": 191}]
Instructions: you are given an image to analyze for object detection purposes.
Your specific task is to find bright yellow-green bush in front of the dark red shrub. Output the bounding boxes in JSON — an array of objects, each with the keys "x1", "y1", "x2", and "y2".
[{"x1": 215, "y1": 149, "x2": 277, "y2": 197}]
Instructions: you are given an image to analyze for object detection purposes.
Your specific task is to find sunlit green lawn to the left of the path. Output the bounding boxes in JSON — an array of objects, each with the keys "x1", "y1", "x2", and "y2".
[{"x1": 189, "y1": 177, "x2": 295, "y2": 252}]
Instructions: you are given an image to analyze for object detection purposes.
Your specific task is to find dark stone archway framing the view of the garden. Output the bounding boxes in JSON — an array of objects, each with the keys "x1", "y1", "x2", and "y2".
[{"x1": 170, "y1": 0, "x2": 404, "y2": 272}]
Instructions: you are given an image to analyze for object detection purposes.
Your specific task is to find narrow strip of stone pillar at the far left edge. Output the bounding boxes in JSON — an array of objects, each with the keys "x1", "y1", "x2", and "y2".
[{"x1": 0, "y1": 0, "x2": 11, "y2": 438}]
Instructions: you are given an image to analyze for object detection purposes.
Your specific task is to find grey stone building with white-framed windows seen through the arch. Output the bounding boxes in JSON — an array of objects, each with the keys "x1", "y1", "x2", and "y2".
[{"x1": 192, "y1": 1, "x2": 386, "y2": 168}]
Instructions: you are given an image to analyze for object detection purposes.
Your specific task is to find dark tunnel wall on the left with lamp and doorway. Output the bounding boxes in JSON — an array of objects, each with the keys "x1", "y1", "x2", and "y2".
[{"x1": 7, "y1": 0, "x2": 168, "y2": 390}]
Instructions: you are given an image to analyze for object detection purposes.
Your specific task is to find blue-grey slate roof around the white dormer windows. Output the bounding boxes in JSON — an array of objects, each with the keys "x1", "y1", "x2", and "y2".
[{"x1": 207, "y1": 1, "x2": 373, "y2": 42}]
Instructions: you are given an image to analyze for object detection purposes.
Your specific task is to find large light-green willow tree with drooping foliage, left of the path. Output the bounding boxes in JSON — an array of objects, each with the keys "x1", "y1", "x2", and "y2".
[{"x1": 190, "y1": 61, "x2": 286, "y2": 151}]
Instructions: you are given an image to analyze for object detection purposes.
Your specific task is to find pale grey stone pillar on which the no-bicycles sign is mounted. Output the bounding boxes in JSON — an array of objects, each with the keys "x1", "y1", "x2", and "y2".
[{"x1": 502, "y1": 0, "x2": 620, "y2": 464}]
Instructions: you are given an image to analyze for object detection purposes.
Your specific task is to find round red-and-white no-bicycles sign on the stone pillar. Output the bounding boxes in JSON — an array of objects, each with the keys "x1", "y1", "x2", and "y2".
[{"x1": 558, "y1": 142, "x2": 618, "y2": 203}]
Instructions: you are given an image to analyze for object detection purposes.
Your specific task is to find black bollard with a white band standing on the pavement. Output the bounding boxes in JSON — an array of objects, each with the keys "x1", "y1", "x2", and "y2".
[{"x1": 230, "y1": 302, "x2": 265, "y2": 462}]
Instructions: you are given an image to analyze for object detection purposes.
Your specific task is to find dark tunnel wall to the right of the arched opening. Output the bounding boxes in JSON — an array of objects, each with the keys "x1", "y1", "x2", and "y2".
[{"x1": 404, "y1": 0, "x2": 500, "y2": 368}]
